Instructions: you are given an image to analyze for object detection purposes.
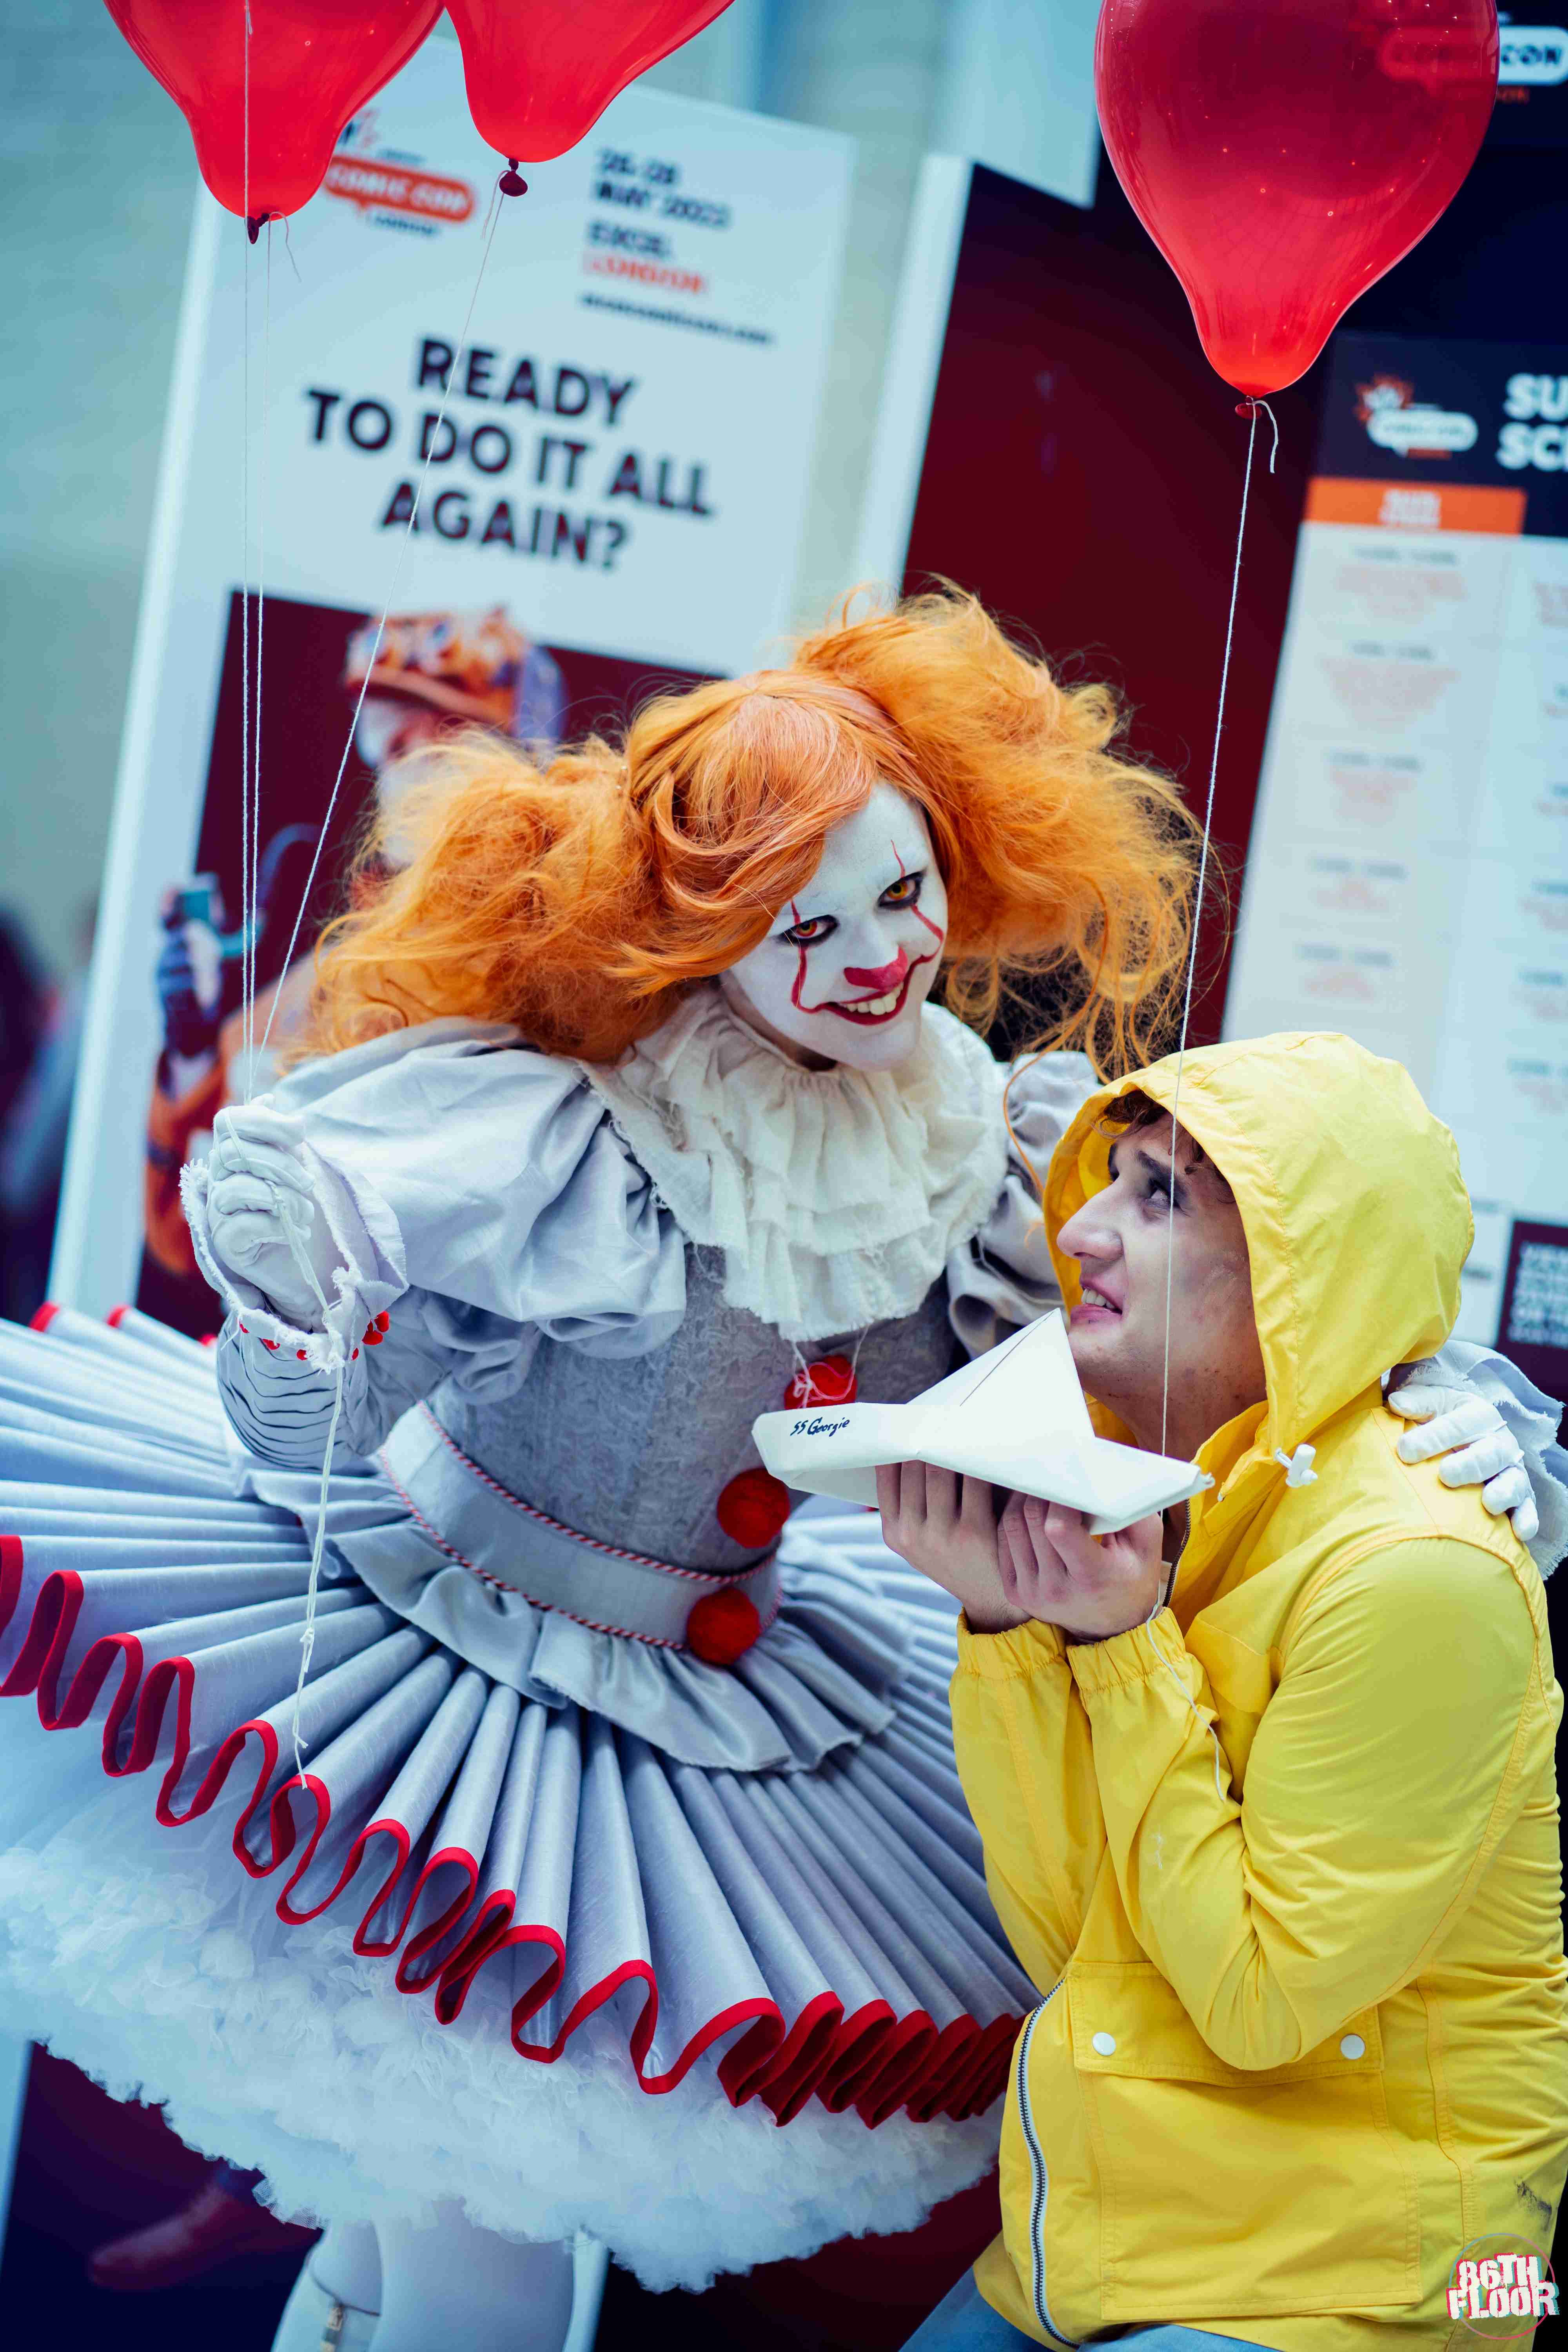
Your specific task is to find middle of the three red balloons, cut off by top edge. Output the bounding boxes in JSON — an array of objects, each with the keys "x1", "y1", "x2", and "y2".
[{"x1": 449, "y1": 0, "x2": 729, "y2": 162}]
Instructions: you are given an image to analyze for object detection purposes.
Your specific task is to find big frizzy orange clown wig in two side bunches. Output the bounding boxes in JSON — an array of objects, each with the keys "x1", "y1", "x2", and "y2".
[{"x1": 303, "y1": 590, "x2": 1196, "y2": 1068}]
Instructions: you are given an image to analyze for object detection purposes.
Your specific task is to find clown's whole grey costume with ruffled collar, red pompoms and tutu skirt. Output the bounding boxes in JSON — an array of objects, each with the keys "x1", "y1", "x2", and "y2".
[{"x1": 0, "y1": 988, "x2": 1091, "y2": 2284}]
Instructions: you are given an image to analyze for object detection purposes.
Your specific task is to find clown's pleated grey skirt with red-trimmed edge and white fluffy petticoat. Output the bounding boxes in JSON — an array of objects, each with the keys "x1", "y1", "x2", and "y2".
[{"x1": 0, "y1": 1315, "x2": 1034, "y2": 2284}]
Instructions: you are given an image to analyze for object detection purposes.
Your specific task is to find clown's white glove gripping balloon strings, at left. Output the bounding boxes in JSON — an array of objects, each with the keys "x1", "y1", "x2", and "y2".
[{"x1": 207, "y1": 1103, "x2": 343, "y2": 1331}]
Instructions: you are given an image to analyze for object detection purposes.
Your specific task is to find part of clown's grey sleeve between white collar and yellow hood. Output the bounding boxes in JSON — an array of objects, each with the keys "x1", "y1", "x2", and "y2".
[{"x1": 947, "y1": 1054, "x2": 1100, "y2": 1355}]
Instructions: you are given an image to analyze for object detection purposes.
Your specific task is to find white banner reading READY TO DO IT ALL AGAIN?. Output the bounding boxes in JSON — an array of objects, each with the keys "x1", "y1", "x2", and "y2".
[{"x1": 52, "y1": 42, "x2": 853, "y2": 1334}]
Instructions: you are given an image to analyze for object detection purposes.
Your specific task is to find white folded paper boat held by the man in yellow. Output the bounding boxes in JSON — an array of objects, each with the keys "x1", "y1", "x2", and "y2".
[{"x1": 752, "y1": 1312, "x2": 1210, "y2": 1536}]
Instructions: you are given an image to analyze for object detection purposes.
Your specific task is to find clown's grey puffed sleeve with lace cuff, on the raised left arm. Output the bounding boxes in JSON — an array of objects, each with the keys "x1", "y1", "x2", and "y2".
[{"x1": 186, "y1": 1021, "x2": 686, "y2": 1468}]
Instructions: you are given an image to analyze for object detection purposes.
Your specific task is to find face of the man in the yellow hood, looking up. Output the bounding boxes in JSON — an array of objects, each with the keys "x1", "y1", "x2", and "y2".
[{"x1": 1058, "y1": 1120, "x2": 1267, "y2": 1451}]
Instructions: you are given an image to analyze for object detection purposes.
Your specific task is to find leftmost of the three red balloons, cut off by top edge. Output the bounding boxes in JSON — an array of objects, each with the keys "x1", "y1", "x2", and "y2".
[{"x1": 106, "y1": 0, "x2": 442, "y2": 221}]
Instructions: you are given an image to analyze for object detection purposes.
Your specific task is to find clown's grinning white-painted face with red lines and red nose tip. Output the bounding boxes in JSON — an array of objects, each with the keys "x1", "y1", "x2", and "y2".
[{"x1": 719, "y1": 783, "x2": 947, "y2": 1070}]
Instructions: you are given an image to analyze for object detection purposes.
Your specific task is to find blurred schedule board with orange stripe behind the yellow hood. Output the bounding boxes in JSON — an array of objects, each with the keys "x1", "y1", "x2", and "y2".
[{"x1": 1225, "y1": 334, "x2": 1568, "y2": 1397}]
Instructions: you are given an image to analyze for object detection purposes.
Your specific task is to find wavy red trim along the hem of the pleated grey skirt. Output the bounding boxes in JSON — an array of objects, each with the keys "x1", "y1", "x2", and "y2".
[{"x1": 0, "y1": 1536, "x2": 1023, "y2": 2129}]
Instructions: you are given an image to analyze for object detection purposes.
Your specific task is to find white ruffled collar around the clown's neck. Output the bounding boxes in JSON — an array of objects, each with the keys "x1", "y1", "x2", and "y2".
[{"x1": 578, "y1": 985, "x2": 1006, "y2": 1341}]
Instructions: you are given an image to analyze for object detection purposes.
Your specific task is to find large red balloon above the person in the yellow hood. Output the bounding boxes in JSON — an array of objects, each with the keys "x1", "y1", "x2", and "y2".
[{"x1": 1096, "y1": 0, "x2": 1497, "y2": 395}]
